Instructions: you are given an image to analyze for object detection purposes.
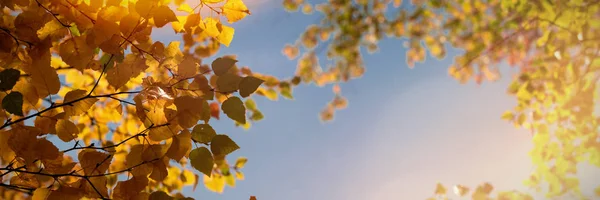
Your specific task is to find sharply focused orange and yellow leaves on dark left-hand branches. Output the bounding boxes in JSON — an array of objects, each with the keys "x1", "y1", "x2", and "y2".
[{"x1": 0, "y1": 0, "x2": 265, "y2": 199}]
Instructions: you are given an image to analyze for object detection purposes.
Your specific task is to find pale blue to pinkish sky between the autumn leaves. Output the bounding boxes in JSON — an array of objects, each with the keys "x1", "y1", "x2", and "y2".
[{"x1": 148, "y1": 0, "x2": 600, "y2": 200}]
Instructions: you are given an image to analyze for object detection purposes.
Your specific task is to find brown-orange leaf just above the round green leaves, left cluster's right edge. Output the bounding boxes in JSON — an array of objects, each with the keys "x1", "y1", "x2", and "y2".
[{"x1": 174, "y1": 96, "x2": 203, "y2": 128}]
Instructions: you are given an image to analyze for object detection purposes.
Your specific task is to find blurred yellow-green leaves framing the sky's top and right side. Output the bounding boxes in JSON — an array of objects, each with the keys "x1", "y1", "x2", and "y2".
[{"x1": 283, "y1": 0, "x2": 600, "y2": 198}]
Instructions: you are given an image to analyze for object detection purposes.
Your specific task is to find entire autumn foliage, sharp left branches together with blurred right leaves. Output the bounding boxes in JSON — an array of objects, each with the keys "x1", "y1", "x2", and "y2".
[{"x1": 0, "y1": 0, "x2": 600, "y2": 199}]
